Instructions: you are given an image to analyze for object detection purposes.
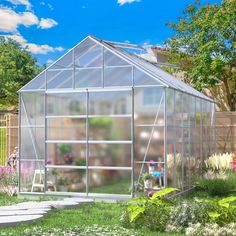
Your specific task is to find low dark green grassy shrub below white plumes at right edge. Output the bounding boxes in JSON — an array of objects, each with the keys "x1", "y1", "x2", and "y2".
[{"x1": 196, "y1": 172, "x2": 236, "y2": 197}]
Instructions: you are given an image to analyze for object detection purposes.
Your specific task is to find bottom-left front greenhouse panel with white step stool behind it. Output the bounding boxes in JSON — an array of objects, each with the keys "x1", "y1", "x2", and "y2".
[{"x1": 20, "y1": 161, "x2": 45, "y2": 192}]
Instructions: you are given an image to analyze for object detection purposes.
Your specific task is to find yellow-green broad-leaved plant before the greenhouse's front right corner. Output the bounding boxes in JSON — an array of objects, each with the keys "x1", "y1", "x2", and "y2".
[{"x1": 127, "y1": 188, "x2": 178, "y2": 231}]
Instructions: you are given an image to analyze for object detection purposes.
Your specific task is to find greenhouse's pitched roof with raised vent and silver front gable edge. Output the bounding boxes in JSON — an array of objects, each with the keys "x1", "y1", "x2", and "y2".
[{"x1": 19, "y1": 35, "x2": 214, "y2": 102}]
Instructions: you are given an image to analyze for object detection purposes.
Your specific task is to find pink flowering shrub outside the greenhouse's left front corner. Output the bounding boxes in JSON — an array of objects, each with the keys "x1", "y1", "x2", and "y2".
[{"x1": 0, "y1": 147, "x2": 19, "y2": 196}]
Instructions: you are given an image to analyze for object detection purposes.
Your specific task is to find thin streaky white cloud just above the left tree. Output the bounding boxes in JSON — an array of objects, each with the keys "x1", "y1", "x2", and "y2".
[{"x1": 3, "y1": 34, "x2": 64, "y2": 55}]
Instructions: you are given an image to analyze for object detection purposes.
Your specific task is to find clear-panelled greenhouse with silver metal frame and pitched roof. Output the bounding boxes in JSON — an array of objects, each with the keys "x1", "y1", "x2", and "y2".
[{"x1": 19, "y1": 36, "x2": 215, "y2": 199}]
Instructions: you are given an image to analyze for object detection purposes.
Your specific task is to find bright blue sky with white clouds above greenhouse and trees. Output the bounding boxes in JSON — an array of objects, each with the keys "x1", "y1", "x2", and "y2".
[{"x1": 0, "y1": 0, "x2": 220, "y2": 64}]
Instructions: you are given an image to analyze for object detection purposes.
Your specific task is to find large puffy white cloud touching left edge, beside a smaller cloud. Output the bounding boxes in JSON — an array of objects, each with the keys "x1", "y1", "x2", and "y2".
[{"x1": 0, "y1": 7, "x2": 39, "y2": 32}]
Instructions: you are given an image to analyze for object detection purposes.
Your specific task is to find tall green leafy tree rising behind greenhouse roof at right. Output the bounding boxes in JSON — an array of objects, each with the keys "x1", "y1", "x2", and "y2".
[{"x1": 166, "y1": 0, "x2": 236, "y2": 111}]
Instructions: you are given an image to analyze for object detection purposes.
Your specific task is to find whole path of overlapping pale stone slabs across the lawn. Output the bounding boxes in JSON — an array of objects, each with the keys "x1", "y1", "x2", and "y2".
[{"x1": 0, "y1": 198, "x2": 94, "y2": 227}]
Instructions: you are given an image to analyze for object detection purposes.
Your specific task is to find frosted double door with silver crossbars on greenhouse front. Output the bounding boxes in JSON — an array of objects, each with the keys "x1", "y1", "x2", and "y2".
[{"x1": 45, "y1": 89, "x2": 133, "y2": 197}]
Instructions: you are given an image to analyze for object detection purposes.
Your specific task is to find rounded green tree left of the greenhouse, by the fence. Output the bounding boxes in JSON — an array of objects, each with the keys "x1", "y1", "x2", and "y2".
[{"x1": 0, "y1": 37, "x2": 41, "y2": 108}]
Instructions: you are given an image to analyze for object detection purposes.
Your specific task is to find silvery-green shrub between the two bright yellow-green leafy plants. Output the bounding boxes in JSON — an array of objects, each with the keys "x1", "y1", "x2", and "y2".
[{"x1": 169, "y1": 200, "x2": 210, "y2": 228}]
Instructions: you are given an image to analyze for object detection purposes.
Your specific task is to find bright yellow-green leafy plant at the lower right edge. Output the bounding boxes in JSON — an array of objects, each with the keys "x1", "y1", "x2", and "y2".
[{"x1": 198, "y1": 196, "x2": 236, "y2": 225}]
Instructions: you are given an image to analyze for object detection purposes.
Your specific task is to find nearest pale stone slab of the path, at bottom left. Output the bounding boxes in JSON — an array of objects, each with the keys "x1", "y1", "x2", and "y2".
[{"x1": 0, "y1": 215, "x2": 43, "y2": 227}]
